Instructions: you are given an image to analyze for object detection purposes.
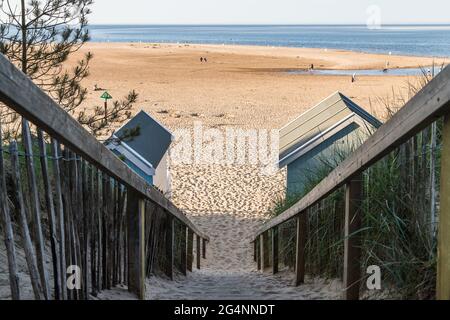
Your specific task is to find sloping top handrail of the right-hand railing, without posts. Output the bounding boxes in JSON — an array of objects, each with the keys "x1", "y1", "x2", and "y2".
[{"x1": 253, "y1": 67, "x2": 450, "y2": 241}]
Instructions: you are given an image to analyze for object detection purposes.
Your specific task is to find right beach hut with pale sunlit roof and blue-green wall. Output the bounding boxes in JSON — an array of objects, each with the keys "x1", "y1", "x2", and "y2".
[{"x1": 279, "y1": 92, "x2": 381, "y2": 197}]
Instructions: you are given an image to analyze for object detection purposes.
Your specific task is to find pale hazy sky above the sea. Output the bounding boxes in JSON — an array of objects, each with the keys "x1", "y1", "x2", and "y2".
[{"x1": 90, "y1": 0, "x2": 450, "y2": 24}]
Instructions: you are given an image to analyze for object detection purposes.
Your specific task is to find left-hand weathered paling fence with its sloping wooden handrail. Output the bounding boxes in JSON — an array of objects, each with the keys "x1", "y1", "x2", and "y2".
[{"x1": 0, "y1": 55, "x2": 209, "y2": 300}]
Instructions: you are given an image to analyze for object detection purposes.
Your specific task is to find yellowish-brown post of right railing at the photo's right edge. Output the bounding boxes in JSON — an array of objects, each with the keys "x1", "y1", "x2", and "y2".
[{"x1": 436, "y1": 114, "x2": 450, "y2": 300}]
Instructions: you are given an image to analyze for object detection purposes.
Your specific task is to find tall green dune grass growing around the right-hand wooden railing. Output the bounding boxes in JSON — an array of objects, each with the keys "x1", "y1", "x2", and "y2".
[{"x1": 272, "y1": 69, "x2": 442, "y2": 299}]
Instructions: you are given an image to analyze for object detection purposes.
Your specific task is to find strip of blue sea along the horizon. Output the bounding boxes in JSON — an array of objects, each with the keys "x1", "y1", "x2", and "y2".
[{"x1": 89, "y1": 25, "x2": 450, "y2": 57}]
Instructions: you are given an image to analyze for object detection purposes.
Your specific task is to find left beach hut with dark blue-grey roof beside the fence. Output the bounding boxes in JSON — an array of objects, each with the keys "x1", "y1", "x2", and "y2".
[{"x1": 106, "y1": 111, "x2": 173, "y2": 196}]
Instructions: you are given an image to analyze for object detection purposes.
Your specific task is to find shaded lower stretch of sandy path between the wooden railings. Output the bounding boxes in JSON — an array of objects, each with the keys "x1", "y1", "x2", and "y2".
[{"x1": 147, "y1": 213, "x2": 340, "y2": 300}]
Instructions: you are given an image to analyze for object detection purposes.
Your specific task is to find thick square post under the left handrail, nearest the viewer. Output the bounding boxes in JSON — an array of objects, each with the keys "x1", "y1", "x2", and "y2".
[{"x1": 127, "y1": 189, "x2": 145, "y2": 299}]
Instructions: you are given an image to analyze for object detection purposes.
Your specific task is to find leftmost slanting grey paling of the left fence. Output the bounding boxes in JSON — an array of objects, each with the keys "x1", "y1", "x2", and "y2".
[{"x1": 0, "y1": 122, "x2": 20, "y2": 300}]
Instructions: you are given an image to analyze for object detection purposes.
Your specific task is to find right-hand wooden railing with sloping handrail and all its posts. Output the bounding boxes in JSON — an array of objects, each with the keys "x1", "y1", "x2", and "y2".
[{"x1": 253, "y1": 67, "x2": 450, "y2": 299}]
